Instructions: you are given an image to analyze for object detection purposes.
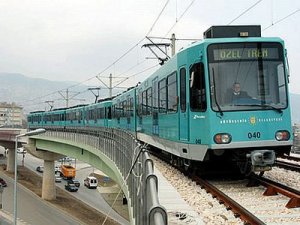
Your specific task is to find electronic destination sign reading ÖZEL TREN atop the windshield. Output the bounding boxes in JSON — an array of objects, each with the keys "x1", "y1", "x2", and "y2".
[{"x1": 213, "y1": 48, "x2": 279, "y2": 61}]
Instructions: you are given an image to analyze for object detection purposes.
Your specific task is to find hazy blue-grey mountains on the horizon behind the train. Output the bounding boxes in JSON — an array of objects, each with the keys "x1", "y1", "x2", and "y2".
[{"x1": 0, "y1": 73, "x2": 300, "y2": 124}]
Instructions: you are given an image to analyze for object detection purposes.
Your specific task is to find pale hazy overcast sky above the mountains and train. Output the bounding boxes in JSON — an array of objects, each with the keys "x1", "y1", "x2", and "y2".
[{"x1": 0, "y1": 0, "x2": 300, "y2": 94}]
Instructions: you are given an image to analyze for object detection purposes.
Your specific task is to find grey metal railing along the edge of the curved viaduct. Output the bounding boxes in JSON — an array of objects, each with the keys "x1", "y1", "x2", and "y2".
[{"x1": 39, "y1": 128, "x2": 168, "y2": 225}]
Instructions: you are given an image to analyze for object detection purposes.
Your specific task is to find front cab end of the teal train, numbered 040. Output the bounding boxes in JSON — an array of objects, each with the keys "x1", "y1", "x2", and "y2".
[{"x1": 185, "y1": 27, "x2": 292, "y2": 171}]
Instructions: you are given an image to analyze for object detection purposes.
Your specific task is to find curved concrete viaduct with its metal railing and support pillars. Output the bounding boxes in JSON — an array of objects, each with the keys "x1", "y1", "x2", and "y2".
[{"x1": 0, "y1": 128, "x2": 167, "y2": 225}]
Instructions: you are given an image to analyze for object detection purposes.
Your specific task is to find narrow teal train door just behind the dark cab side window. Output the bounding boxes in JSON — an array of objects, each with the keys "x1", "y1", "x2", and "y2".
[{"x1": 179, "y1": 67, "x2": 189, "y2": 141}]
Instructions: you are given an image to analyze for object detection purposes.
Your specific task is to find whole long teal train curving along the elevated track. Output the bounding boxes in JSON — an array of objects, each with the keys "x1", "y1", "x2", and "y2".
[{"x1": 28, "y1": 26, "x2": 293, "y2": 173}]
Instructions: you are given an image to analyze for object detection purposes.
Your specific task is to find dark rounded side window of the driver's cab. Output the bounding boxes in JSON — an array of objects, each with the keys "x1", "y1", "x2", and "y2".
[{"x1": 190, "y1": 62, "x2": 207, "y2": 111}]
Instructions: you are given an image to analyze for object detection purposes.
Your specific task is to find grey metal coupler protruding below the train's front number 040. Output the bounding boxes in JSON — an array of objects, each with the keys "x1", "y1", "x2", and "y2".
[{"x1": 247, "y1": 150, "x2": 275, "y2": 172}]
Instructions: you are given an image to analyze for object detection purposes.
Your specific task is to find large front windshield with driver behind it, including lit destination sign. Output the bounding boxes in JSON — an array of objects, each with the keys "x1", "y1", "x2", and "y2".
[{"x1": 208, "y1": 42, "x2": 287, "y2": 112}]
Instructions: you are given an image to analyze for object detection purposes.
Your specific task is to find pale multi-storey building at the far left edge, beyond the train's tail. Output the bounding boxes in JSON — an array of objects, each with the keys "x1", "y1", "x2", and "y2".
[{"x1": 0, "y1": 102, "x2": 23, "y2": 128}]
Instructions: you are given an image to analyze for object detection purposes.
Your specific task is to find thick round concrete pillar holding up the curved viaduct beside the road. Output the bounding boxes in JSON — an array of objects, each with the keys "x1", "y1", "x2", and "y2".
[{"x1": 42, "y1": 160, "x2": 56, "y2": 200}]
